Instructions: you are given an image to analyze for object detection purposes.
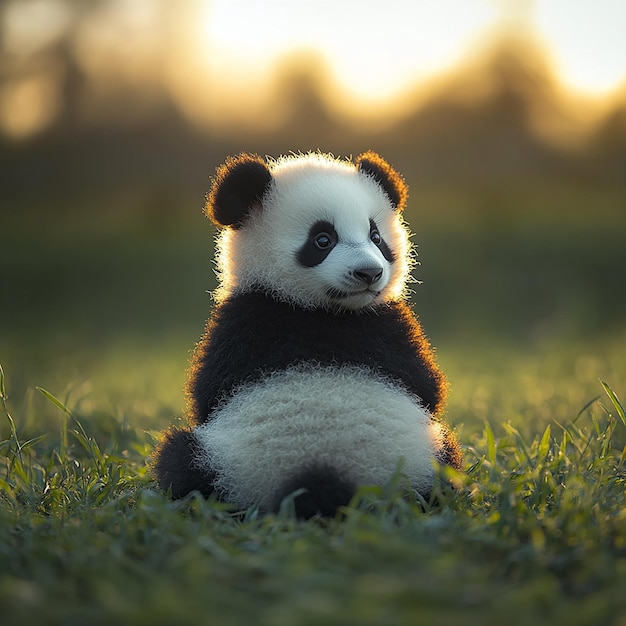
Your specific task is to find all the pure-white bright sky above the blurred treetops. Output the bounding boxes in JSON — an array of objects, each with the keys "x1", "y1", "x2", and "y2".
[{"x1": 200, "y1": 0, "x2": 626, "y2": 99}]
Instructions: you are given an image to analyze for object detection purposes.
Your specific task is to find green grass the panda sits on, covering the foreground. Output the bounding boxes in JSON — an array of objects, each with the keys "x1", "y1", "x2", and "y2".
[{"x1": 0, "y1": 356, "x2": 626, "y2": 626}]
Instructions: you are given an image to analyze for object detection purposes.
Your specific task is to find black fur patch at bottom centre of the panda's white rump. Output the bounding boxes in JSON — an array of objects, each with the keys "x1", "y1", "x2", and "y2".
[{"x1": 271, "y1": 465, "x2": 356, "y2": 519}]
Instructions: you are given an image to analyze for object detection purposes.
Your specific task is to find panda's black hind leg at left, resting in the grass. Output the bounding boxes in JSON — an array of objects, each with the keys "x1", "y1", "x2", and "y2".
[{"x1": 152, "y1": 428, "x2": 215, "y2": 498}]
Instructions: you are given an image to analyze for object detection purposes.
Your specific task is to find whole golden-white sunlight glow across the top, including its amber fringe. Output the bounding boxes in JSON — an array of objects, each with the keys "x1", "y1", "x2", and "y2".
[{"x1": 0, "y1": 0, "x2": 626, "y2": 136}]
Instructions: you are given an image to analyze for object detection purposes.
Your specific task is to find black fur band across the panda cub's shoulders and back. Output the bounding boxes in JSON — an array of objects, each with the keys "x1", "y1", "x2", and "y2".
[{"x1": 187, "y1": 291, "x2": 447, "y2": 425}]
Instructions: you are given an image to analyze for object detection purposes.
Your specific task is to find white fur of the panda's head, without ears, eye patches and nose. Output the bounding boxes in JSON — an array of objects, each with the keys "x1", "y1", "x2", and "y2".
[{"x1": 217, "y1": 154, "x2": 411, "y2": 309}]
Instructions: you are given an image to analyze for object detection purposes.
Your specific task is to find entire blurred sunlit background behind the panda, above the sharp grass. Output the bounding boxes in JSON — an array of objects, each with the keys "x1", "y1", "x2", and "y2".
[{"x1": 0, "y1": 0, "x2": 626, "y2": 427}]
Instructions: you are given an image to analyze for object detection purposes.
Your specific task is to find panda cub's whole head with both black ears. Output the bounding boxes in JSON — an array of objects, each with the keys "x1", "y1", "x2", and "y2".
[{"x1": 206, "y1": 152, "x2": 412, "y2": 310}]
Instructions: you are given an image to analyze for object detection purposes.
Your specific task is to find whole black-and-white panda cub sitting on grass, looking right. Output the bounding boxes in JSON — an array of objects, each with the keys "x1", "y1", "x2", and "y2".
[{"x1": 154, "y1": 152, "x2": 461, "y2": 518}]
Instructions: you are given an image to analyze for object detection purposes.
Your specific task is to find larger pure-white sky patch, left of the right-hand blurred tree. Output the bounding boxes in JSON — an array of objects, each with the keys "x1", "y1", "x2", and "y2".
[{"x1": 203, "y1": 0, "x2": 497, "y2": 100}]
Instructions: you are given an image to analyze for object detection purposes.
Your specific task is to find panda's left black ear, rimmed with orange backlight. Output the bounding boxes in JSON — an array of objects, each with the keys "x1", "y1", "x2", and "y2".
[{"x1": 205, "y1": 153, "x2": 272, "y2": 228}]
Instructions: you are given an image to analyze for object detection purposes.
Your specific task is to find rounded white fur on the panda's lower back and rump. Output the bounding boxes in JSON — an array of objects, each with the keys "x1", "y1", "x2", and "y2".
[{"x1": 194, "y1": 365, "x2": 442, "y2": 508}]
